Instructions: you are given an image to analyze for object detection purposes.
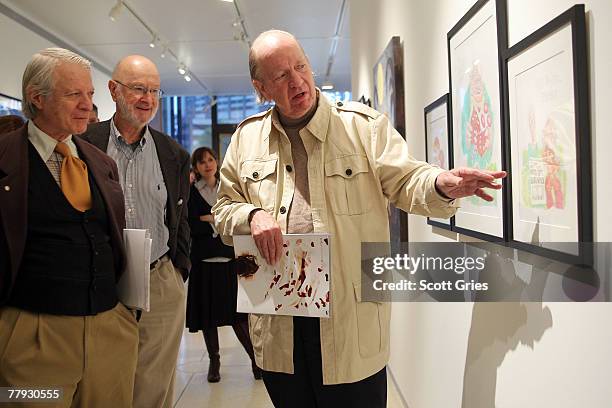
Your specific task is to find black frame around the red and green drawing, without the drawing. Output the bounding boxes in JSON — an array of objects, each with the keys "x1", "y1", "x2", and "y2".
[{"x1": 447, "y1": 0, "x2": 508, "y2": 242}]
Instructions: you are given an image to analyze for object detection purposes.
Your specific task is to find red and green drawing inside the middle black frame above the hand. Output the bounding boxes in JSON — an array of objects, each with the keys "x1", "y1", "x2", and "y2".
[{"x1": 460, "y1": 63, "x2": 498, "y2": 206}]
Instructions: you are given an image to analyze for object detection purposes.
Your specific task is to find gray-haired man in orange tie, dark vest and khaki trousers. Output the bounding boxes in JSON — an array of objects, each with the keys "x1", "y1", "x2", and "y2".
[{"x1": 0, "y1": 48, "x2": 138, "y2": 407}]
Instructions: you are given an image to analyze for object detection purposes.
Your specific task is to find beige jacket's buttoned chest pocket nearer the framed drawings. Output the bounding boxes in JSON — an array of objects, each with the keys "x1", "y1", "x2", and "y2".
[{"x1": 325, "y1": 154, "x2": 371, "y2": 215}]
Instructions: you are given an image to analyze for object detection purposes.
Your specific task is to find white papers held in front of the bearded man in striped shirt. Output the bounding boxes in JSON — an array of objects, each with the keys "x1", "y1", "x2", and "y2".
[{"x1": 117, "y1": 228, "x2": 153, "y2": 312}]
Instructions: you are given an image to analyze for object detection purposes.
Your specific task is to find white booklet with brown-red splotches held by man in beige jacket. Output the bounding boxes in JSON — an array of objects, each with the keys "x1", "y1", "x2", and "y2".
[{"x1": 234, "y1": 234, "x2": 330, "y2": 317}]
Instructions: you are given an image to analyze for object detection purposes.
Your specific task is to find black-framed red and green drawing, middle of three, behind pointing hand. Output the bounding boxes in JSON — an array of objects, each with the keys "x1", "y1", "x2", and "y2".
[{"x1": 447, "y1": 0, "x2": 507, "y2": 241}]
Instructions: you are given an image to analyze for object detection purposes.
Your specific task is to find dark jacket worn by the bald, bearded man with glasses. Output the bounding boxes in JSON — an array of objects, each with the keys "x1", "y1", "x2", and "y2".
[{"x1": 82, "y1": 119, "x2": 191, "y2": 280}]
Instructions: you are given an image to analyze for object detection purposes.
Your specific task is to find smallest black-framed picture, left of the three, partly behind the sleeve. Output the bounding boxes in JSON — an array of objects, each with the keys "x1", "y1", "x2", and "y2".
[{"x1": 425, "y1": 94, "x2": 453, "y2": 230}]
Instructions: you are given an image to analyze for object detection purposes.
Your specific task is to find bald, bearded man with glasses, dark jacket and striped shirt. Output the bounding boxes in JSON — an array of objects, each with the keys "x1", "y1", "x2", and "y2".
[{"x1": 83, "y1": 55, "x2": 191, "y2": 408}]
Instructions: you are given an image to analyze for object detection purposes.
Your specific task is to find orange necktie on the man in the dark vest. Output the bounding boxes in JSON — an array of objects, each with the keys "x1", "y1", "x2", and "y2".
[{"x1": 55, "y1": 142, "x2": 91, "y2": 211}]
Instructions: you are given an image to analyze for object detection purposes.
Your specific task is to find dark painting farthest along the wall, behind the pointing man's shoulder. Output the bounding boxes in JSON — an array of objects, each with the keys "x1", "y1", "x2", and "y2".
[{"x1": 373, "y1": 36, "x2": 408, "y2": 250}]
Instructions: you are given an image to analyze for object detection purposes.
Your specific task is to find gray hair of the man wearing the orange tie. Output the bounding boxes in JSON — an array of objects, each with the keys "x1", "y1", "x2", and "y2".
[{"x1": 21, "y1": 48, "x2": 91, "y2": 119}]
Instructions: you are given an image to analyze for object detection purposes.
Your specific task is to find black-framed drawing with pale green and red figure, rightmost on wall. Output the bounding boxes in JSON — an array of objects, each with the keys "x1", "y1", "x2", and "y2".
[{"x1": 504, "y1": 5, "x2": 593, "y2": 264}]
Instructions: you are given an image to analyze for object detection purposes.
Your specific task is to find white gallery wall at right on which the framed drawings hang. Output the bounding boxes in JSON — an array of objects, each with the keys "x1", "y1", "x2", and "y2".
[{"x1": 350, "y1": 0, "x2": 612, "y2": 408}]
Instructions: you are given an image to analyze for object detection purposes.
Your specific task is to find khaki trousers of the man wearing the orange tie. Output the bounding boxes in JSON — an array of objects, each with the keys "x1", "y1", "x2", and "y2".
[{"x1": 0, "y1": 303, "x2": 138, "y2": 408}]
